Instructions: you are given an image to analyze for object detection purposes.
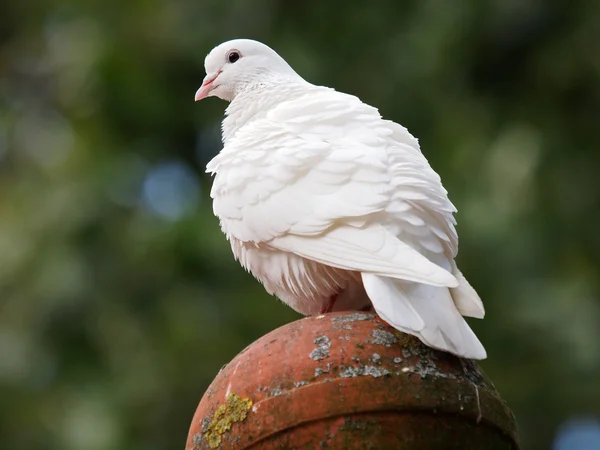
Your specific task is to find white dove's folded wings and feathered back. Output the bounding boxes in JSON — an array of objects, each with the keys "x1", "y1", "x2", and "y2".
[{"x1": 207, "y1": 88, "x2": 457, "y2": 287}]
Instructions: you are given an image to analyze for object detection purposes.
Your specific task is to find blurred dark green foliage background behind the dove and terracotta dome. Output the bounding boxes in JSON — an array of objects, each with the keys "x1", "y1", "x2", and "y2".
[{"x1": 0, "y1": 0, "x2": 600, "y2": 450}]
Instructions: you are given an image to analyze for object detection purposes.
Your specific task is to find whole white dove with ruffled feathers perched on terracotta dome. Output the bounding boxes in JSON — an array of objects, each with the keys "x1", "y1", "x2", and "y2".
[{"x1": 195, "y1": 39, "x2": 486, "y2": 359}]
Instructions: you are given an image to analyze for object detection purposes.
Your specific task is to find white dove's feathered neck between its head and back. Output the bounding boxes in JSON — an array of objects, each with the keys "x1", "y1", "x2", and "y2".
[{"x1": 222, "y1": 76, "x2": 315, "y2": 143}]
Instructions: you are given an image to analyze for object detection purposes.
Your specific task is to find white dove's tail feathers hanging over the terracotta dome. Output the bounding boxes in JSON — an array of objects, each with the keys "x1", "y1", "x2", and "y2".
[{"x1": 362, "y1": 266, "x2": 487, "y2": 359}]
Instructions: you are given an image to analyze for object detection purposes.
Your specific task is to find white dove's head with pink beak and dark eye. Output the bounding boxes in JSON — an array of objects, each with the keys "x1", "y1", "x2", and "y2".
[{"x1": 195, "y1": 39, "x2": 300, "y2": 101}]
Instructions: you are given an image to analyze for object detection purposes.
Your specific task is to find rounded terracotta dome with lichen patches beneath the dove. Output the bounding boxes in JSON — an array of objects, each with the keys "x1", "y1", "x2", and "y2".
[{"x1": 186, "y1": 312, "x2": 518, "y2": 450}]
